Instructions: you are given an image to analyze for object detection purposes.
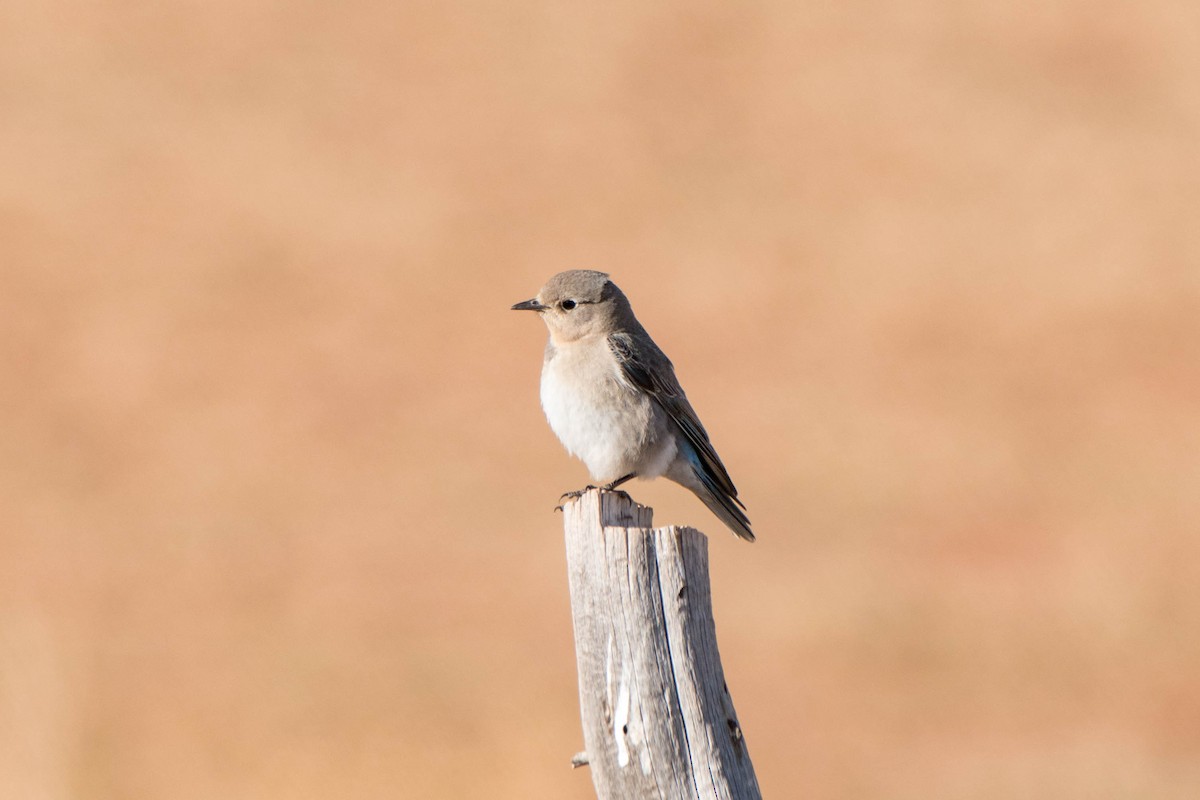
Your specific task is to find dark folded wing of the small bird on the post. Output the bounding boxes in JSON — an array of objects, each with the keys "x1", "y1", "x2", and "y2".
[{"x1": 608, "y1": 333, "x2": 745, "y2": 509}]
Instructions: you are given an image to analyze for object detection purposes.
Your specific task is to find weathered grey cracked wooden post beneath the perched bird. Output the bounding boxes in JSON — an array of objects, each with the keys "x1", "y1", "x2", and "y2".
[{"x1": 563, "y1": 489, "x2": 762, "y2": 800}]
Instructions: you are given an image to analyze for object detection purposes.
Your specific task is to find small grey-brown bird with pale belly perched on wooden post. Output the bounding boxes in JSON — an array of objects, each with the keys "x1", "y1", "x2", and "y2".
[{"x1": 512, "y1": 270, "x2": 755, "y2": 542}]
